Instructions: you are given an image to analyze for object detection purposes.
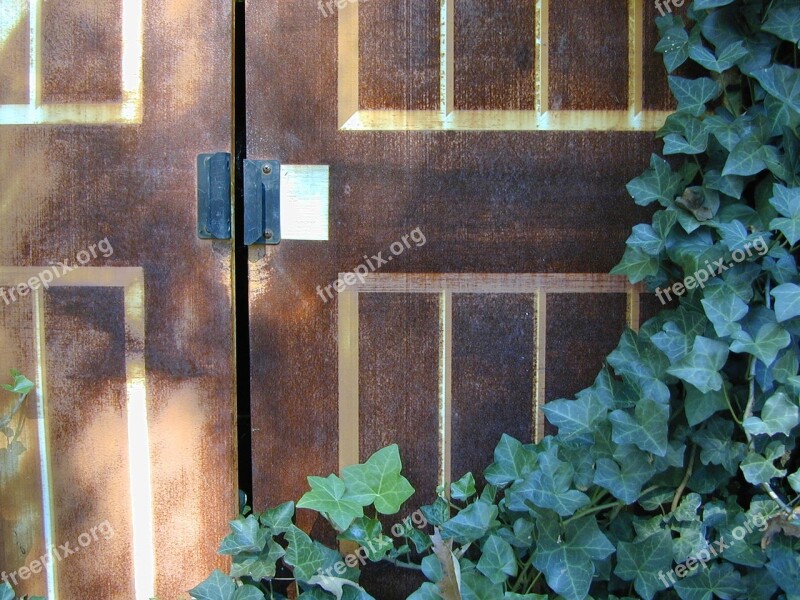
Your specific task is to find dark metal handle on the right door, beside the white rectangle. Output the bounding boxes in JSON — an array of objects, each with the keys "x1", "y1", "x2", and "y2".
[{"x1": 244, "y1": 160, "x2": 281, "y2": 246}]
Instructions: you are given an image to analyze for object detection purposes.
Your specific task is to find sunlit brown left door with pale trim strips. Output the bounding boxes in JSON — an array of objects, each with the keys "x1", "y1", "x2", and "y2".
[{"x1": 0, "y1": 0, "x2": 236, "y2": 600}]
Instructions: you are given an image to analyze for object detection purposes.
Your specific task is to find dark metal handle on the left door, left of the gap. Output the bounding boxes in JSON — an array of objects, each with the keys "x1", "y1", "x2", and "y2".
[{"x1": 197, "y1": 152, "x2": 231, "y2": 240}]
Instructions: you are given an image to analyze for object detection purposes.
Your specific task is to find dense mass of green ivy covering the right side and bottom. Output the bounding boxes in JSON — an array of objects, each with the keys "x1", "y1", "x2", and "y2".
[{"x1": 192, "y1": 0, "x2": 800, "y2": 600}]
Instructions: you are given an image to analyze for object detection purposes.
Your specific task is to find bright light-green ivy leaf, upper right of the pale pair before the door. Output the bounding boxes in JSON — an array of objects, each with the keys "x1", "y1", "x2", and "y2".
[{"x1": 340, "y1": 444, "x2": 414, "y2": 516}]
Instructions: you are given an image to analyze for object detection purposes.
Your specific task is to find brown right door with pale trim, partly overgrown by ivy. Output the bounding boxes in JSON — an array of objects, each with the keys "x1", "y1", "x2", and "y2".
[{"x1": 246, "y1": 0, "x2": 670, "y2": 600}]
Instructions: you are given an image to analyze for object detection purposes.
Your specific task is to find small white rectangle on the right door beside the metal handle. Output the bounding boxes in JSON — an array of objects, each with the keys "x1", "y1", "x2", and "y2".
[{"x1": 281, "y1": 165, "x2": 330, "y2": 240}]
